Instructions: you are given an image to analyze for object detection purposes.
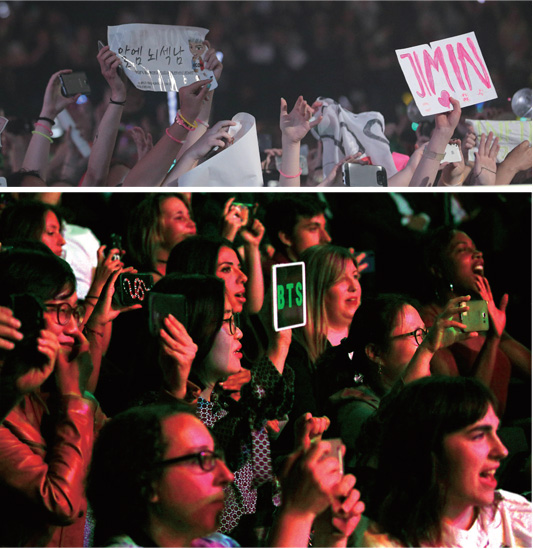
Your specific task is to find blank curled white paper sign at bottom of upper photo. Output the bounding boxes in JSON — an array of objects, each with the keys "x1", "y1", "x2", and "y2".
[{"x1": 176, "y1": 112, "x2": 263, "y2": 187}]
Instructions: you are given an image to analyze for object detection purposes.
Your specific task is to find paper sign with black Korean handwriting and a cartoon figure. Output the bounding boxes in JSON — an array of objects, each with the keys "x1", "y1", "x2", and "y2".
[{"x1": 107, "y1": 23, "x2": 217, "y2": 92}]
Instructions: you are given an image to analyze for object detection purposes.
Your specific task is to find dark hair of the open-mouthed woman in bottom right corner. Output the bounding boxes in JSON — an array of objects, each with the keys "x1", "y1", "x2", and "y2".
[{"x1": 374, "y1": 376, "x2": 495, "y2": 547}]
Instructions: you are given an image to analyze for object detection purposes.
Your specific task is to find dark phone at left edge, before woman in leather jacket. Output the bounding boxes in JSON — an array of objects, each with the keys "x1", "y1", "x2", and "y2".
[{"x1": 9, "y1": 294, "x2": 48, "y2": 367}]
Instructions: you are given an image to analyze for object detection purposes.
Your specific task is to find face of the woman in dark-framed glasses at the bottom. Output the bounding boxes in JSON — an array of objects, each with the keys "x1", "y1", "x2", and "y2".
[{"x1": 150, "y1": 413, "x2": 233, "y2": 543}]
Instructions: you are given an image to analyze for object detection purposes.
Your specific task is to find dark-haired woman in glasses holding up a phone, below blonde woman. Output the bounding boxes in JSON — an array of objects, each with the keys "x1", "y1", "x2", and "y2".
[{"x1": 317, "y1": 294, "x2": 477, "y2": 474}]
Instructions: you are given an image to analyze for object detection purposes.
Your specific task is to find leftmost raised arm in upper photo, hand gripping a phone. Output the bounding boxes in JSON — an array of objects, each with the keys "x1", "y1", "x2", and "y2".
[{"x1": 22, "y1": 69, "x2": 79, "y2": 181}]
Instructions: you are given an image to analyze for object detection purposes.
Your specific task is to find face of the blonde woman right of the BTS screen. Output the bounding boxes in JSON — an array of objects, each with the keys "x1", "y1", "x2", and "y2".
[{"x1": 325, "y1": 260, "x2": 361, "y2": 328}]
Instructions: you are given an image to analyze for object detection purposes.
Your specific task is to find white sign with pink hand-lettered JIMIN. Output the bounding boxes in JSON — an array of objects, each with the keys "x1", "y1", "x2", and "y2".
[{"x1": 396, "y1": 32, "x2": 498, "y2": 116}]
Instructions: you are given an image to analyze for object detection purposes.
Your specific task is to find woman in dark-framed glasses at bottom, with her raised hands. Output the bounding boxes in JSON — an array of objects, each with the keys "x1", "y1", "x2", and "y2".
[{"x1": 87, "y1": 402, "x2": 364, "y2": 547}]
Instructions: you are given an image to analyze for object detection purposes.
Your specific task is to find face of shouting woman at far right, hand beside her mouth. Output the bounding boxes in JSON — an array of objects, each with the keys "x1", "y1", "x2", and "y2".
[{"x1": 438, "y1": 231, "x2": 484, "y2": 295}]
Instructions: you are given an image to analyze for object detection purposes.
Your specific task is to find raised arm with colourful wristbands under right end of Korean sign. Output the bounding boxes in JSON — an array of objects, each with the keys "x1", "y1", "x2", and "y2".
[{"x1": 123, "y1": 80, "x2": 211, "y2": 187}]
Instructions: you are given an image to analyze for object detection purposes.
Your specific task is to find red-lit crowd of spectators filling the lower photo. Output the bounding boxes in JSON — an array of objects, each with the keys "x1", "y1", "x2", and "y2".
[{"x1": 0, "y1": 192, "x2": 532, "y2": 547}]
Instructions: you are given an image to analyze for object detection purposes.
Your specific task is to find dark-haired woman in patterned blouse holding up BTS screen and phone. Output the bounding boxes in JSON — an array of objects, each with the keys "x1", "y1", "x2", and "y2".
[{"x1": 143, "y1": 274, "x2": 294, "y2": 545}]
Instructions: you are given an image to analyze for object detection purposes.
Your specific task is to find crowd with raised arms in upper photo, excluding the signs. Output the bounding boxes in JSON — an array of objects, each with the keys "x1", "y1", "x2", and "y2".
[{"x1": 0, "y1": 2, "x2": 531, "y2": 187}]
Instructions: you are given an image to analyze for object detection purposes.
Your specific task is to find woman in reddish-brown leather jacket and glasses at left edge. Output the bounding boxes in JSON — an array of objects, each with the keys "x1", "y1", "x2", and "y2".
[{"x1": 0, "y1": 250, "x2": 97, "y2": 547}]
